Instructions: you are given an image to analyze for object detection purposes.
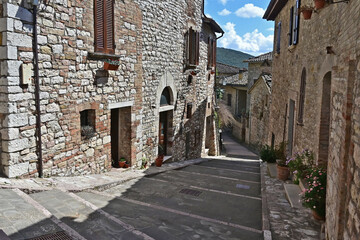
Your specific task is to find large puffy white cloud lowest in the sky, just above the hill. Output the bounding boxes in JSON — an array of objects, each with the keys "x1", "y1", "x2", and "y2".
[{"x1": 219, "y1": 22, "x2": 274, "y2": 56}]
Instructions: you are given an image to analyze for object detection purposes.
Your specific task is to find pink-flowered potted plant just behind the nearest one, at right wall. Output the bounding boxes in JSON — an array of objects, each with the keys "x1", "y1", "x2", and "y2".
[{"x1": 286, "y1": 149, "x2": 314, "y2": 184}]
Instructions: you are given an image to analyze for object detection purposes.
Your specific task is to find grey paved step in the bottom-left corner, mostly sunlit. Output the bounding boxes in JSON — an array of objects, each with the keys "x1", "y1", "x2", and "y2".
[{"x1": 0, "y1": 189, "x2": 63, "y2": 239}]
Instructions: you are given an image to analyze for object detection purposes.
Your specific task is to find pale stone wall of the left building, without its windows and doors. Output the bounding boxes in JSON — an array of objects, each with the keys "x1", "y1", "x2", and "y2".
[{"x1": 0, "y1": 0, "x2": 215, "y2": 177}]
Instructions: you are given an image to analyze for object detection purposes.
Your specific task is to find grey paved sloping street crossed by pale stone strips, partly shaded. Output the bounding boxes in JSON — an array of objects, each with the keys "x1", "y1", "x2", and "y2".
[{"x1": 0, "y1": 158, "x2": 263, "y2": 240}]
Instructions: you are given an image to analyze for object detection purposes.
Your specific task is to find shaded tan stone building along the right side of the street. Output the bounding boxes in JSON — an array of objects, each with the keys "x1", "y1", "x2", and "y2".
[{"x1": 264, "y1": 0, "x2": 360, "y2": 239}]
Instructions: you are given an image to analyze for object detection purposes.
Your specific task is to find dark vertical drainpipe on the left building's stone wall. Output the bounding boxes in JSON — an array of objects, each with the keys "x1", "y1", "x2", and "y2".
[{"x1": 31, "y1": 0, "x2": 43, "y2": 178}]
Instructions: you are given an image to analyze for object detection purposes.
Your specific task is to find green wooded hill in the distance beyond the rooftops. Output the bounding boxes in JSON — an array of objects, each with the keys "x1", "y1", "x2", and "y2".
[{"x1": 216, "y1": 48, "x2": 253, "y2": 68}]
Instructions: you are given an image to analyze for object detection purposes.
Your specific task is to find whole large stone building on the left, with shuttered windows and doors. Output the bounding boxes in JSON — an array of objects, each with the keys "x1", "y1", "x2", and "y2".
[{"x1": 0, "y1": 0, "x2": 223, "y2": 177}]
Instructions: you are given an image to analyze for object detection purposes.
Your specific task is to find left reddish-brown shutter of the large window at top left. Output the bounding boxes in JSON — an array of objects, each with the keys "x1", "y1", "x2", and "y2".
[{"x1": 94, "y1": 0, "x2": 105, "y2": 52}]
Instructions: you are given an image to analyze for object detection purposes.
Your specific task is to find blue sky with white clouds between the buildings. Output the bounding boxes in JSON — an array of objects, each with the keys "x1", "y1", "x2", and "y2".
[{"x1": 205, "y1": 0, "x2": 274, "y2": 56}]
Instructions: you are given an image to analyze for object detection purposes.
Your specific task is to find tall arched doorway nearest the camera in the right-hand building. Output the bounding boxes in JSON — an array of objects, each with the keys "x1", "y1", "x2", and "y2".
[{"x1": 318, "y1": 72, "x2": 331, "y2": 164}]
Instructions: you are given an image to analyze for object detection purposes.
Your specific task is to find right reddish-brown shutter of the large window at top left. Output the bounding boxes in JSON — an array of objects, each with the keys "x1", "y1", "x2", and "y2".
[{"x1": 104, "y1": 0, "x2": 115, "y2": 53}]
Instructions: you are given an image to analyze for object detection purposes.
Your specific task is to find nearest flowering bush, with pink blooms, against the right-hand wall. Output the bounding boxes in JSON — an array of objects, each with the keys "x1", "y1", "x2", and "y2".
[{"x1": 302, "y1": 166, "x2": 326, "y2": 217}]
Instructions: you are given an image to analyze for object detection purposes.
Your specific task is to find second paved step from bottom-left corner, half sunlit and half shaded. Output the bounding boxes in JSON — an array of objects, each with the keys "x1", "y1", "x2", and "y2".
[{"x1": 30, "y1": 190, "x2": 141, "y2": 239}]
